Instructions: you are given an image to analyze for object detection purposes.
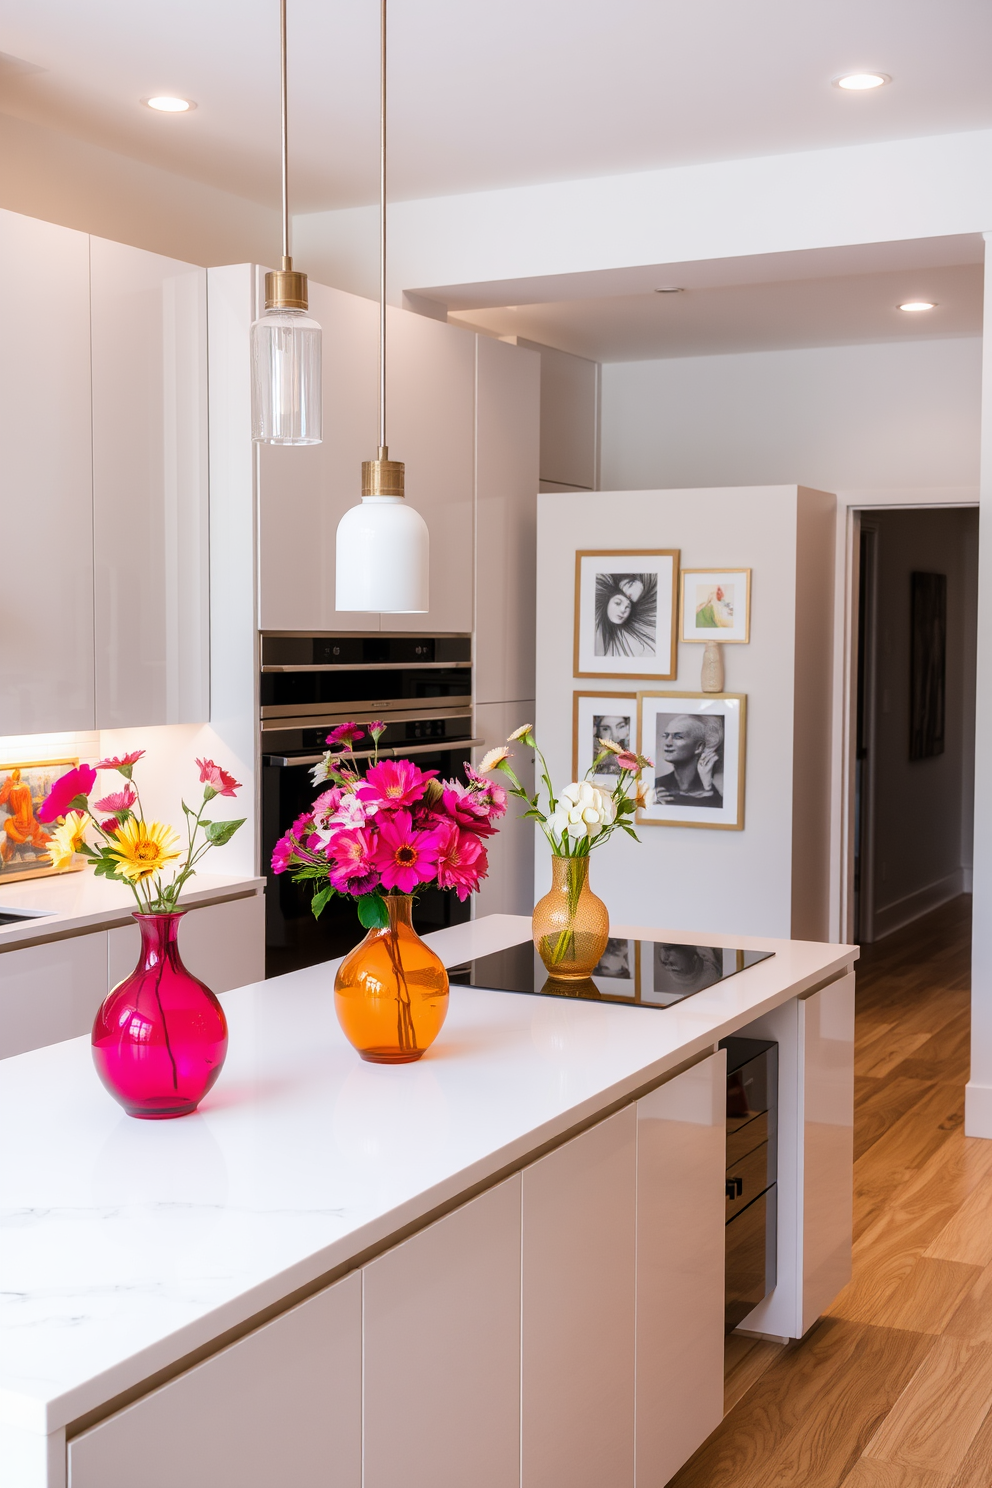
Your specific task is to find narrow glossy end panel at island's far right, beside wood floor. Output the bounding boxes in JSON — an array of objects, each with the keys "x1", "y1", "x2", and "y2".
[{"x1": 799, "y1": 972, "x2": 854, "y2": 1333}]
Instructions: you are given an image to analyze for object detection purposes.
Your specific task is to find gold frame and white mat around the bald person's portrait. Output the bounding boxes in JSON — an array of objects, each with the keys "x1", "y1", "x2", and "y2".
[{"x1": 637, "y1": 692, "x2": 748, "y2": 832}]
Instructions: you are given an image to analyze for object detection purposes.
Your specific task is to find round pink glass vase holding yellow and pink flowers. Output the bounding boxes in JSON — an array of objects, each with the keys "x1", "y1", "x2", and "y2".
[{"x1": 92, "y1": 909, "x2": 228, "y2": 1120}]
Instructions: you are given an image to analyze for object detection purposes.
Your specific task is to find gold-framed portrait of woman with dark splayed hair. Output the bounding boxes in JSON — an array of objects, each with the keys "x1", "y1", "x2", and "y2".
[{"x1": 574, "y1": 548, "x2": 678, "y2": 682}]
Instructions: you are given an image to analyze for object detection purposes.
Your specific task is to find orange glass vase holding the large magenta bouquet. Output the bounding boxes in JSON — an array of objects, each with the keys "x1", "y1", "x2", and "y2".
[{"x1": 335, "y1": 894, "x2": 448, "y2": 1064}]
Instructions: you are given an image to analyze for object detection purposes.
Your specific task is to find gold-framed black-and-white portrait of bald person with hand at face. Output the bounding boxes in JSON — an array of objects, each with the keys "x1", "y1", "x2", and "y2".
[{"x1": 637, "y1": 692, "x2": 747, "y2": 832}]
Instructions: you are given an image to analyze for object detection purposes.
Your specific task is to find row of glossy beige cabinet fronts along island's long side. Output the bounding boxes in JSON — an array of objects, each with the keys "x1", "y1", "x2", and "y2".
[{"x1": 68, "y1": 1052, "x2": 726, "y2": 1488}]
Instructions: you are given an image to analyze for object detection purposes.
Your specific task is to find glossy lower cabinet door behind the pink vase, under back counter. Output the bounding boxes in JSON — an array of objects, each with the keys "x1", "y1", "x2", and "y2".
[{"x1": 107, "y1": 894, "x2": 265, "y2": 992}]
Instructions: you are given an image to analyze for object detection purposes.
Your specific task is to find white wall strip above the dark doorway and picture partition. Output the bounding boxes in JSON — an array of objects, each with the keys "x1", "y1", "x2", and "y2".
[{"x1": 601, "y1": 338, "x2": 982, "y2": 491}]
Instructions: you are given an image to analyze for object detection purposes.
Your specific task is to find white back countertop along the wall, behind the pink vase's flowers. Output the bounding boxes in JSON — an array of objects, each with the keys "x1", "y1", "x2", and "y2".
[{"x1": 0, "y1": 868, "x2": 265, "y2": 952}]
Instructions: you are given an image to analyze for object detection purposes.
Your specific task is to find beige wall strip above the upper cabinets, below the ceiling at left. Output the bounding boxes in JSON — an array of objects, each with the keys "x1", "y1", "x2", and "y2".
[{"x1": 0, "y1": 113, "x2": 280, "y2": 266}]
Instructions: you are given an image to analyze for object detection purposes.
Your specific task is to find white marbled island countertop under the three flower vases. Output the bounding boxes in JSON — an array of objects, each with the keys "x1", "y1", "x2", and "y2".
[{"x1": 0, "y1": 910, "x2": 858, "y2": 1431}]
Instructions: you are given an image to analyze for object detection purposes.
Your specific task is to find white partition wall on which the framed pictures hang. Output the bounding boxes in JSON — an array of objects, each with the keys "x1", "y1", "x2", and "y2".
[{"x1": 532, "y1": 485, "x2": 833, "y2": 939}]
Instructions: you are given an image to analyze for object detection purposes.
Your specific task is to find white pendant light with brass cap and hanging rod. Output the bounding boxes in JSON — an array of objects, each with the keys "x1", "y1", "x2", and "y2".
[{"x1": 335, "y1": 0, "x2": 430, "y2": 615}]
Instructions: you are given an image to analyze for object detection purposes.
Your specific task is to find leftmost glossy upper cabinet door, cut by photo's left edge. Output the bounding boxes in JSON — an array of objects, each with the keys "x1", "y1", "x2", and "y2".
[{"x1": 0, "y1": 211, "x2": 94, "y2": 734}]
